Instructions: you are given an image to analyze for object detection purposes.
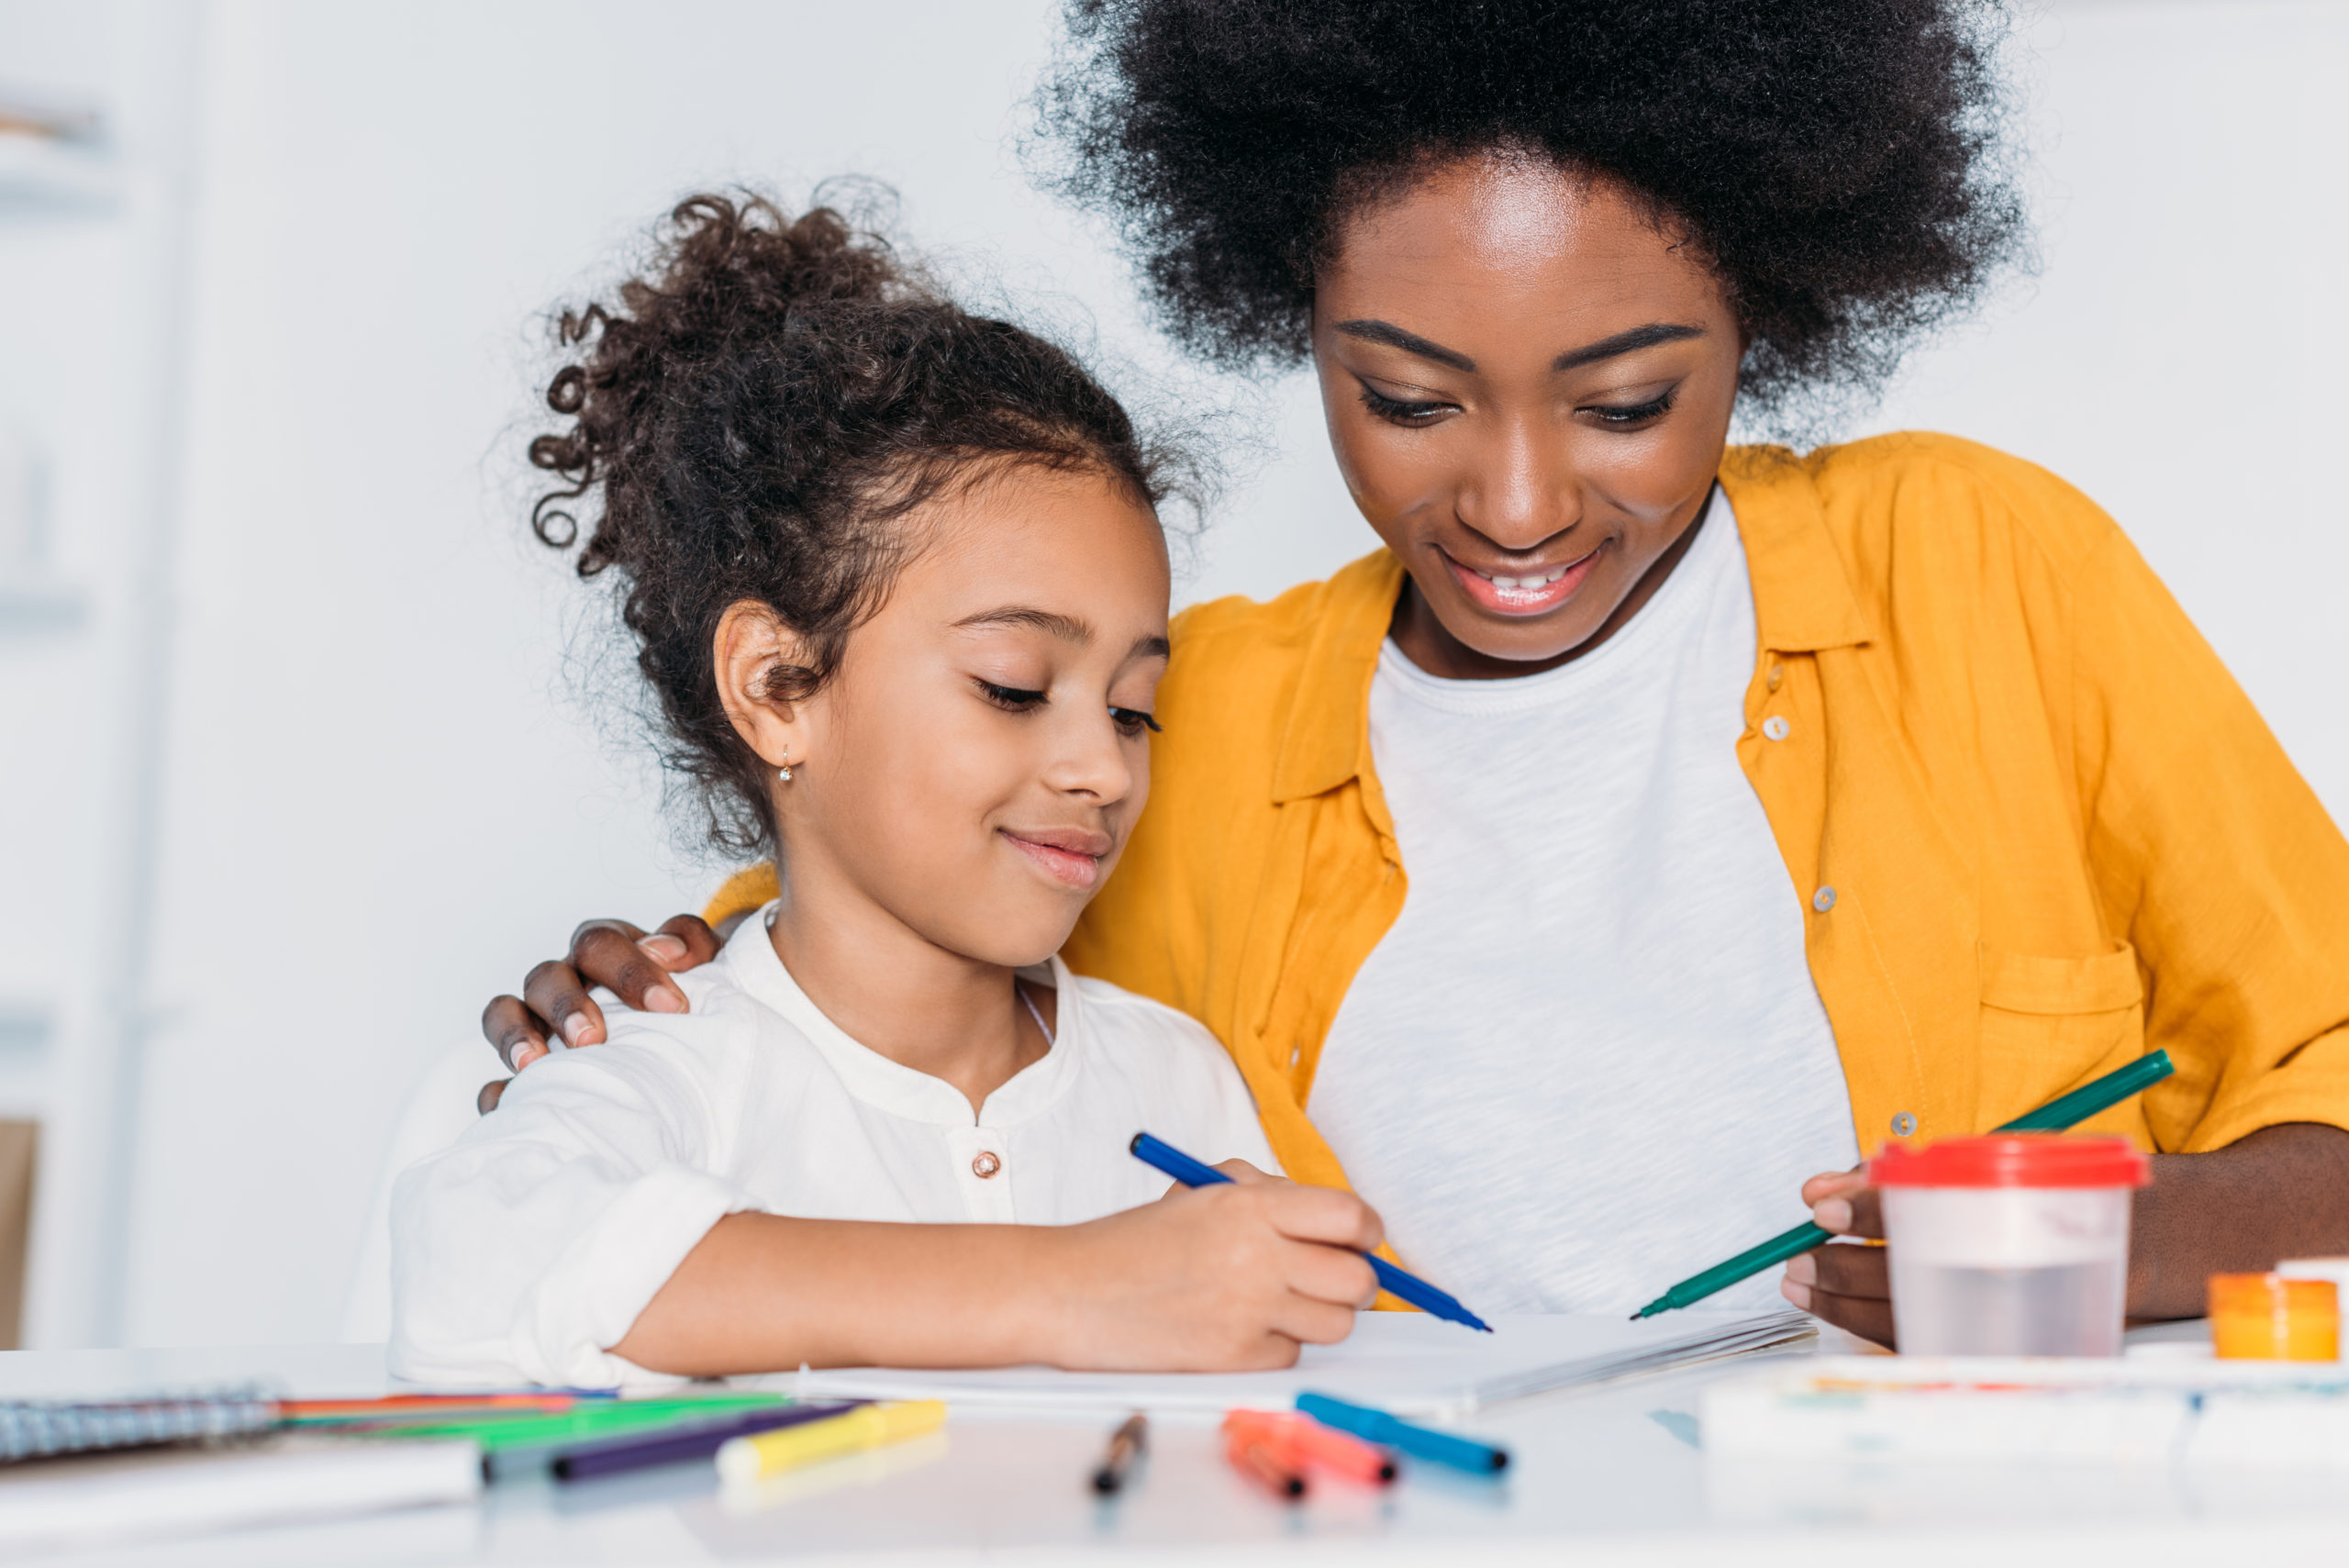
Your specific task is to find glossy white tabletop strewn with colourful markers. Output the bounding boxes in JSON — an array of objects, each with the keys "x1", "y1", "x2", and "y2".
[{"x1": 0, "y1": 1345, "x2": 2349, "y2": 1568}]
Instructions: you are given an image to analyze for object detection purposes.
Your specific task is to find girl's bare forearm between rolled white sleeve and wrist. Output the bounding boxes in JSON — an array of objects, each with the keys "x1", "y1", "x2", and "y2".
[{"x1": 611, "y1": 1214, "x2": 1069, "y2": 1378}]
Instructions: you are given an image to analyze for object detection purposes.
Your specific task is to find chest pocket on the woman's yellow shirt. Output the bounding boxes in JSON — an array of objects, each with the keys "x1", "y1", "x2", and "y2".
[{"x1": 1976, "y1": 941, "x2": 2144, "y2": 1129}]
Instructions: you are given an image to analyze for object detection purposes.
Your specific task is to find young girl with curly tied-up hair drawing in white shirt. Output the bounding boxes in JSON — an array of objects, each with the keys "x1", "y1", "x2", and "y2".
[{"x1": 393, "y1": 197, "x2": 1379, "y2": 1385}]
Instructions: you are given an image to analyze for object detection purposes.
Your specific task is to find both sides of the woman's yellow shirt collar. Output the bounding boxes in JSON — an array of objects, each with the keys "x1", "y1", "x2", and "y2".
[{"x1": 1274, "y1": 446, "x2": 1875, "y2": 803}]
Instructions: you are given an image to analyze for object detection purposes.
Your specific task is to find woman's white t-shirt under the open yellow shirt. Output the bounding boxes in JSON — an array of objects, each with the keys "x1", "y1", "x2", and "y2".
[{"x1": 1308, "y1": 491, "x2": 1858, "y2": 1317}]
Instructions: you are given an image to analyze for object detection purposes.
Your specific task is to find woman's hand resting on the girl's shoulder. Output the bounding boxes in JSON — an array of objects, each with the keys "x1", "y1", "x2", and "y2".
[{"x1": 477, "y1": 916, "x2": 721, "y2": 1115}]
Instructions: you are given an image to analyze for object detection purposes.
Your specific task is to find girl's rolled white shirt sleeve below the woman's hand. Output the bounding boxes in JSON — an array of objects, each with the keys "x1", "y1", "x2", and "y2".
[{"x1": 390, "y1": 1042, "x2": 761, "y2": 1387}]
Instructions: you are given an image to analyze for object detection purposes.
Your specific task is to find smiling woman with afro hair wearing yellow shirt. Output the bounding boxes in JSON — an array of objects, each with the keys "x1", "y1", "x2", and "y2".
[{"x1": 484, "y1": 0, "x2": 2349, "y2": 1340}]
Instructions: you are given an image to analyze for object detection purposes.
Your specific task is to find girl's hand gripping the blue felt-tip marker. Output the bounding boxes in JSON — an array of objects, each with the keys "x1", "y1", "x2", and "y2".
[{"x1": 1052, "y1": 1160, "x2": 1386, "y2": 1371}]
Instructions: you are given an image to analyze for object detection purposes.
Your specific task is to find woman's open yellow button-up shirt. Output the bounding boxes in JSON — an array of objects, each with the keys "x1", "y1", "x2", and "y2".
[{"x1": 712, "y1": 434, "x2": 2349, "y2": 1185}]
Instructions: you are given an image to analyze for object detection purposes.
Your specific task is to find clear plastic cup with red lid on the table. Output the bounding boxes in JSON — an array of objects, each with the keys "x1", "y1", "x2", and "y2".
[{"x1": 1867, "y1": 1134, "x2": 2152, "y2": 1357}]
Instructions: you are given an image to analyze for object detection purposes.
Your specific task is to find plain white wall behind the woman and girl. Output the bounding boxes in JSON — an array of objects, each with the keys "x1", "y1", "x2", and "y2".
[{"x1": 0, "y1": 0, "x2": 2349, "y2": 1345}]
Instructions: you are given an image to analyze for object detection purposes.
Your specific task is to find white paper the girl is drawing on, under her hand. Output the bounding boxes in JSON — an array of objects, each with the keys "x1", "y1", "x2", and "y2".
[{"x1": 763, "y1": 1312, "x2": 1818, "y2": 1418}]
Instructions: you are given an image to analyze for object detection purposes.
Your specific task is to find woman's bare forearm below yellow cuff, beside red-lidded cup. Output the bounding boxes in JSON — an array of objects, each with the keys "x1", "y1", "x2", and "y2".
[{"x1": 2128, "y1": 1122, "x2": 2349, "y2": 1317}]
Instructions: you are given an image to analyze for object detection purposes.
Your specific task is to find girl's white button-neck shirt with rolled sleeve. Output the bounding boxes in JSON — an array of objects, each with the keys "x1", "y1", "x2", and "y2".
[{"x1": 393, "y1": 917, "x2": 1280, "y2": 1387}]
